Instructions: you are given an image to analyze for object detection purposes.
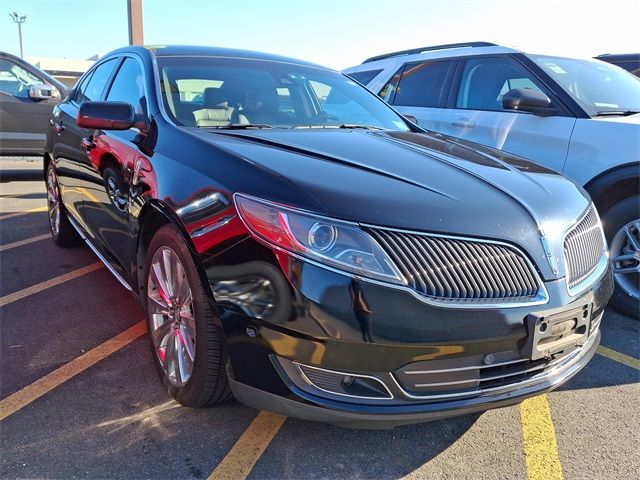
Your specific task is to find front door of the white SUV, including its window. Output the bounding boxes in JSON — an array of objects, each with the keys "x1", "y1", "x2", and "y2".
[{"x1": 437, "y1": 56, "x2": 576, "y2": 172}]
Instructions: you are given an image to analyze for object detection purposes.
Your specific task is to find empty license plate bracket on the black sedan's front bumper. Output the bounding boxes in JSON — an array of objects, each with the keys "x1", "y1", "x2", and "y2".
[{"x1": 521, "y1": 303, "x2": 593, "y2": 360}]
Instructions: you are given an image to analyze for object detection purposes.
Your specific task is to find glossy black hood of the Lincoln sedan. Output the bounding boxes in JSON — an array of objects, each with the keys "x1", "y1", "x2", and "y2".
[{"x1": 192, "y1": 128, "x2": 589, "y2": 278}]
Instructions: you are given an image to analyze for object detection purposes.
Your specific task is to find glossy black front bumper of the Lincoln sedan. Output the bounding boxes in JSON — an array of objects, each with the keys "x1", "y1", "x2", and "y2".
[{"x1": 212, "y1": 255, "x2": 613, "y2": 428}]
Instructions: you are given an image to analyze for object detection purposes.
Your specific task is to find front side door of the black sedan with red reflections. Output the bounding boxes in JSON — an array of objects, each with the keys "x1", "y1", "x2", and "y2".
[{"x1": 83, "y1": 56, "x2": 149, "y2": 278}]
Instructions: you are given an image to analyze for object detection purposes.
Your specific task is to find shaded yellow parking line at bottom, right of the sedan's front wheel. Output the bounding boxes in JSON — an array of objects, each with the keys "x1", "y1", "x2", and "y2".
[{"x1": 209, "y1": 411, "x2": 287, "y2": 480}]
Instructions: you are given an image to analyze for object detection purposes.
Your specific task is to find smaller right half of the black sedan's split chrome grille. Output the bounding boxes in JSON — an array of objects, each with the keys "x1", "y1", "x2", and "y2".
[{"x1": 564, "y1": 206, "x2": 605, "y2": 289}]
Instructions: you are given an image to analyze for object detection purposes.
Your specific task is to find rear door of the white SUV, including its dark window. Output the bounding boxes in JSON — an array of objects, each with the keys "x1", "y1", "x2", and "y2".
[{"x1": 378, "y1": 60, "x2": 453, "y2": 131}]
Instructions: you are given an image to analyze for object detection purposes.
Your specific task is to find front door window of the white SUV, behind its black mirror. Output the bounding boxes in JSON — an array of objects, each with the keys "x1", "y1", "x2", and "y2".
[{"x1": 456, "y1": 57, "x2": 544, "y2": 111}]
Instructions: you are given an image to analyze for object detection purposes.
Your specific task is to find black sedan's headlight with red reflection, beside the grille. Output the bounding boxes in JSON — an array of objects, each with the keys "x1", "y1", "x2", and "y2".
[{"x1": 234, "y1": 194, "x2": 406, "y2": 284}]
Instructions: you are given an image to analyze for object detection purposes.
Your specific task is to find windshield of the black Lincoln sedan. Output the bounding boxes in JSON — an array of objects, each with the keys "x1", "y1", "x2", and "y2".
[{"x1": 157, "y1": 56, "x2": 409, "y2": 131}]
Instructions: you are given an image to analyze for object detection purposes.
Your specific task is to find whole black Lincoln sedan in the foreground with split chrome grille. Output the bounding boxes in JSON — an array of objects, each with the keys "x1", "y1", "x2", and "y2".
[{"x1": 44, "y1": 46, "x2": 612, "y2": 426}]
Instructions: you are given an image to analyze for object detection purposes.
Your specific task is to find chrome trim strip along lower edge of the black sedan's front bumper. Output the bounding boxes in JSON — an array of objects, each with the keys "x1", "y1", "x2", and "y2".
[{"x1": 391, "y1": 330, "x2": 597, "y2": 401}]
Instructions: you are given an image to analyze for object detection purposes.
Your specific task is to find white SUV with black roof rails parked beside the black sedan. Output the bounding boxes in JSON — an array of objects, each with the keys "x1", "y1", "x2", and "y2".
[{"x1": 345, "y1": 42, "x2": 640, "y2": 318}]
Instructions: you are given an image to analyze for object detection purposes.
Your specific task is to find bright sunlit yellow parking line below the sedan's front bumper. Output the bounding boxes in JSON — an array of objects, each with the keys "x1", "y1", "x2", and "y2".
[{"x1": 520, "y1": 395, "x2": 563, "y2": 480}]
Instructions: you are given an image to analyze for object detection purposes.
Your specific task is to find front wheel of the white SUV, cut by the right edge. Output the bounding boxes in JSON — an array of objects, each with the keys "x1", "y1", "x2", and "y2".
[{"x1": 602, "y1": 195, "x2": 640, "y2": 320}]
